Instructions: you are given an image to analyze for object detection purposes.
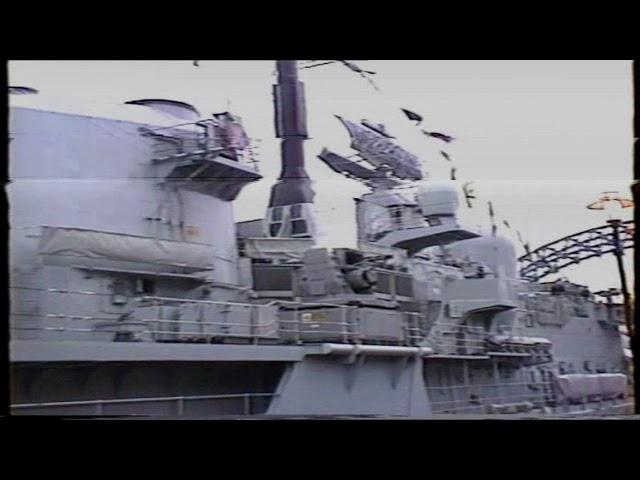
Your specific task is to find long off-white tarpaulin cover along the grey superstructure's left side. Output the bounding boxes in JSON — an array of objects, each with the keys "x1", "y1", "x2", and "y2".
[{"x1": 39, "y1": 227, "x2": 214, "y2": 270}]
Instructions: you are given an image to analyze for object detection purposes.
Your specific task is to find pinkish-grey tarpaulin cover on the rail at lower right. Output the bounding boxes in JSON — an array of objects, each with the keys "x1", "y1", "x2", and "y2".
[{"x1": 554, "y1": 373, "x2": 627, "y2": 401}]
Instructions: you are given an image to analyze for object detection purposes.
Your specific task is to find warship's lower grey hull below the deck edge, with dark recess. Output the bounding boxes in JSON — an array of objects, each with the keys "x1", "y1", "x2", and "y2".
[{"x1": 11, "y1": 341, "x2": 630, "y2": 418}]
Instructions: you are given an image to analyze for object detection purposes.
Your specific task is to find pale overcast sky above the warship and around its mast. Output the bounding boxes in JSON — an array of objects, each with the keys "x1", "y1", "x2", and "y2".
[{"x1": 9, "y1": 60, "x2": 633, "y2": 290}]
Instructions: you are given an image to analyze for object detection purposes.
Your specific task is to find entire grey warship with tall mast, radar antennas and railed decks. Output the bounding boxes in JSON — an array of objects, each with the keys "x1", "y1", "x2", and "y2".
[{"x1": 7, "y1": 61, "x2": 628, "y2": 418}]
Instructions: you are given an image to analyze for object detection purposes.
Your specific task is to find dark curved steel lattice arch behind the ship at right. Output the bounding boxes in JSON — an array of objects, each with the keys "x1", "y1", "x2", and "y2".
[{"x1": 518, "y1": 220, "x2": 635, "y2": 281}]
